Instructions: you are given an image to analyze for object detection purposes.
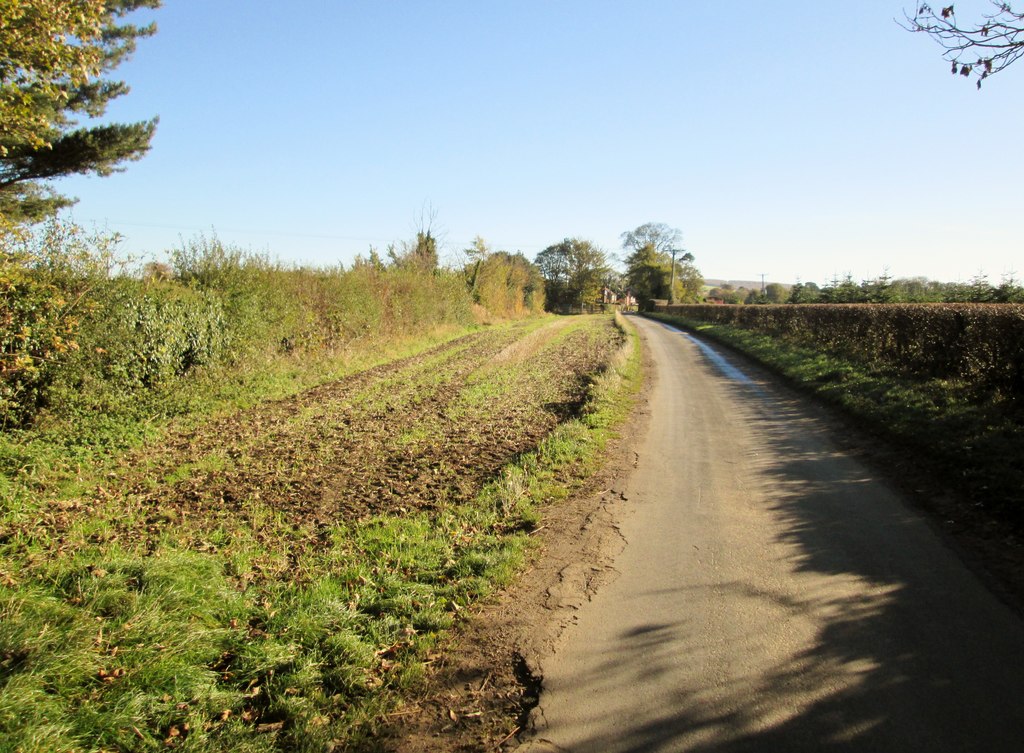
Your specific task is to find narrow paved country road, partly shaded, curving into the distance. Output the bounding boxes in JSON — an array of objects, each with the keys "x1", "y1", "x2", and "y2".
[{"x1": 526, "y1": 319, "x2": 1024, "y2": 753}]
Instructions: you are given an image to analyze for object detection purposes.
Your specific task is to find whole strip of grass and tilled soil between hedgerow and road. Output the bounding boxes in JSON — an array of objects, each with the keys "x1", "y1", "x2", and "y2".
[{"x1": 0, "y1": 317, "x2": 639, "y2": 752}]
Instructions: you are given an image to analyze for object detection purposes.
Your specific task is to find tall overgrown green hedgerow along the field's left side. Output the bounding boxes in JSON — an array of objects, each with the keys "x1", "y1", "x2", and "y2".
[{"x1": 0, "y1": 221, "x2": 524, "y2": 428}]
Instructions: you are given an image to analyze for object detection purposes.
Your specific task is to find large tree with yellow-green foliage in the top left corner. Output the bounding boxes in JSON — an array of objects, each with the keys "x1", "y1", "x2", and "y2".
[{"x1": 0, "y1": 0, "x2": 161, "y2": 226}]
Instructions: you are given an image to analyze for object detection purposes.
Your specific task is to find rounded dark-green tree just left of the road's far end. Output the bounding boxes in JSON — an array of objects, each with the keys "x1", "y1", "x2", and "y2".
[{"x1": 536, "y1": 238, "x2": 608, "y2": 309}]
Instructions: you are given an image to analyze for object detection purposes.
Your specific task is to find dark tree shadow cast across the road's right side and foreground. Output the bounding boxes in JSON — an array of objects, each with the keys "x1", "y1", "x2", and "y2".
[{"x1": 528, "y1": 338, "x2": 1024, "y2": 753}]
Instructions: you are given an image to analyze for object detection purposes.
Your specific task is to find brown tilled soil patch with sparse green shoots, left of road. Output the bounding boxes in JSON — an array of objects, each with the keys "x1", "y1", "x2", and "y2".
[{"x1": 28, "y1": 320, "x2": 617, "y2": 569}]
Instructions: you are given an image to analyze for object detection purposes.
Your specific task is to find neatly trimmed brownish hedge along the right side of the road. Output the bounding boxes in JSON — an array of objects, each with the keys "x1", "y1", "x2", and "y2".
[{"x1": 657, "y1": 303, "x2": 1024, "y2": 395}]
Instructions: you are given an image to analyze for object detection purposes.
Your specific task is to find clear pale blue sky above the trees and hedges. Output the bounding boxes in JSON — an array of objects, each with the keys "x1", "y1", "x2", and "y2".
[{"x1": 57, "y1": 0, "x2": 1024, "y2": 283}]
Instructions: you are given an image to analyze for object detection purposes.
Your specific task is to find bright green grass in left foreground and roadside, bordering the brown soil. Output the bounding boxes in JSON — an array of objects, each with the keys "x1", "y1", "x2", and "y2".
[{"x1": 0, "y1": 318, "x2": 641, "y2": 753}]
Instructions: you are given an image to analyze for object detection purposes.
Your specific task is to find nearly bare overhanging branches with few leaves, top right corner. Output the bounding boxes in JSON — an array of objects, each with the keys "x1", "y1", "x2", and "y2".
[{"x1": 904, "y1": 0, "x2": 1024, "y2": 89}]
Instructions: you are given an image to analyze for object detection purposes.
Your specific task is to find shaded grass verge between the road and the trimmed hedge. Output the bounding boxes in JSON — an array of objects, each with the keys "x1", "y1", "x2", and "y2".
[{"x1": 652, "y1": 315, "x2": 1024, "y2": 533}]
